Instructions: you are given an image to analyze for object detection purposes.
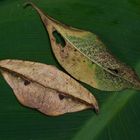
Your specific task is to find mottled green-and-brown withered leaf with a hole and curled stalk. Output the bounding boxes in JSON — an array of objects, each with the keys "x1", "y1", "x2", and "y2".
[{"x1": 26, "y1": 2, "x2": 140, "y2": 91}]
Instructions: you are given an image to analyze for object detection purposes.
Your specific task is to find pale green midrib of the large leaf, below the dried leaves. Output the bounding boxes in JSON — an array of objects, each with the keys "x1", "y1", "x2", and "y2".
[{"x1": 72, "y1": 90, "x2": 135, "y2": 140}]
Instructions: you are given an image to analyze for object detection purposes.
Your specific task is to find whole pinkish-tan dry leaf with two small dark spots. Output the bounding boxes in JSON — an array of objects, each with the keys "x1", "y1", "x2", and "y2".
[{"x1": 0, "y1": 60, "x2": 99, "y2": 116}]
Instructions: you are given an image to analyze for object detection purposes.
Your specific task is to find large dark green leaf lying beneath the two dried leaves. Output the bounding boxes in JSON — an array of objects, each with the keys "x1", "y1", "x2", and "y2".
[{"x1": 0, "y1": 0, "x2": 140, "y2": 140}]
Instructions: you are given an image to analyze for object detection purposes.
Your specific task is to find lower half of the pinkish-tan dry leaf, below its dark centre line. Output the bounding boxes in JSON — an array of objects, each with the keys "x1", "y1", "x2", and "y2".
[{"x1": 2, "y1": 71, "x2": 91, "y2": 116}]
